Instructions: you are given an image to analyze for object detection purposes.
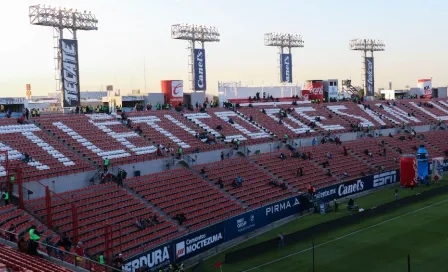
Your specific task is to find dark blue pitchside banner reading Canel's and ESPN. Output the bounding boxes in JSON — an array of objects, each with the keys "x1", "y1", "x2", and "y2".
[{"x1": 316, "y1": 170, "x2": 400, "y2": 202}]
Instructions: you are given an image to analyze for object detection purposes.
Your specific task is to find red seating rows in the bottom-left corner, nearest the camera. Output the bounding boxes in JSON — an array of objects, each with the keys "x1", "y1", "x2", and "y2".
[{"x1": 0, "y1": 244, "x2": 72, "y2": 272}]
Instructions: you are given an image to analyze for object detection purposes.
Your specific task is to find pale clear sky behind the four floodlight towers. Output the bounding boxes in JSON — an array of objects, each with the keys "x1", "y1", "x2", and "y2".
[{"x1": 0, "y1": 0, "x2": 448, "y2": 96}]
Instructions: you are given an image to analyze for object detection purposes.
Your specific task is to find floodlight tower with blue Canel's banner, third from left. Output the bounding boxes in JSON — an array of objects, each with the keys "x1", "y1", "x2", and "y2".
[{"x1": 264, "y1": 33, "x2": 304, "y2": 83}]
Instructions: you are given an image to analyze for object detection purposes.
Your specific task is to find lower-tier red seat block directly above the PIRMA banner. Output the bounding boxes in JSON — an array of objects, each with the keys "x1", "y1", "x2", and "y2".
[{"x1": 194, "y1": 158, "x2": 293, "y2": 208}]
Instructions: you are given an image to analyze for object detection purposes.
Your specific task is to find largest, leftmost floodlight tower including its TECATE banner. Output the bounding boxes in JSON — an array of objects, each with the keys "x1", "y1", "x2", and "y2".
[{"x1": 28, "y1": 5, "x2": 98, "y2": 108}]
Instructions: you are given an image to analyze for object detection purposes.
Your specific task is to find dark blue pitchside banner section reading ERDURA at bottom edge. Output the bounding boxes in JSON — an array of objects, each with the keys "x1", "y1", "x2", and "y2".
[{"x1": 122, "y1": 246, "x2": 170, "y2": 272}]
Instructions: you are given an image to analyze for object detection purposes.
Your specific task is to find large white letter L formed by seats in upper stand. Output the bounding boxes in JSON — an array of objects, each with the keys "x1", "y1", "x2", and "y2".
[{"x1": 53, "y1": 122, "x2": 131, "y2": 159}]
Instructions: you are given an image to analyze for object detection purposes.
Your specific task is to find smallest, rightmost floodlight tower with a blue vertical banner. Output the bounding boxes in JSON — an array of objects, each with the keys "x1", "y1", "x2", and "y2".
[{"x1": 350, "y1": 39, "x2": 386, "y2": 97}]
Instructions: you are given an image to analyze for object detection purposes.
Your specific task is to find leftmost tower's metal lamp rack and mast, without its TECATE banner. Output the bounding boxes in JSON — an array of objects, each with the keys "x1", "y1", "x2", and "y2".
[{"x1": 28, "y1": 5, "x2": 98, "y2": 106}]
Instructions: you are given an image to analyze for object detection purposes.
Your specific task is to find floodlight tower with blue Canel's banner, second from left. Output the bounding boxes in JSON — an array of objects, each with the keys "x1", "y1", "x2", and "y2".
[{"x1": 171, "y1": 24, "x2": 220, "y2": 92}]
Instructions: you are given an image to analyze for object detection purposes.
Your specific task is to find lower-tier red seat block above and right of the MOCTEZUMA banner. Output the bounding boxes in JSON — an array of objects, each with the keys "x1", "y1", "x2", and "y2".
[{"x1": 126, "y1": 169, "x2": 244, "y2": 230}]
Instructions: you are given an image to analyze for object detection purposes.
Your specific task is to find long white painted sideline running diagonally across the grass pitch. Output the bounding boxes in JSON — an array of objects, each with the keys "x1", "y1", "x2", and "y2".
[{"x1": 242, "y1": 199, "x2": 448, "y2": 272}]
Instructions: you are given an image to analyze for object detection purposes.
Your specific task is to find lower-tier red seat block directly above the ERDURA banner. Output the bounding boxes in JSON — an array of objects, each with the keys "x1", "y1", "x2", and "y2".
[{"x1": 26, "y1": 184, "x2": 182, "y2": 257}]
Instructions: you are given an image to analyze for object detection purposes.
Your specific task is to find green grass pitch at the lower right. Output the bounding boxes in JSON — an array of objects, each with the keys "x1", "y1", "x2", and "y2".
[{"x1": 198, "y1": 183, "x2": 448, "y2": 272}]
